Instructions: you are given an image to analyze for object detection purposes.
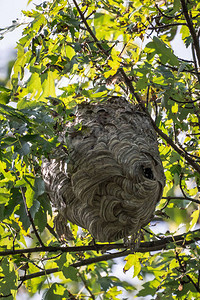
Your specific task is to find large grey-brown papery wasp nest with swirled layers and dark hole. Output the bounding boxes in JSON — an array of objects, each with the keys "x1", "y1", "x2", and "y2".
[{"x1": 42, "y1": 97, "x2": 165, "y2": 242}]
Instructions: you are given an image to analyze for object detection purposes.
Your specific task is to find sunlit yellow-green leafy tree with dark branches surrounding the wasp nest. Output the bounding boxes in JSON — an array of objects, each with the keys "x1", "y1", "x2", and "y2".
[{"x1": 0, "y1": 0, "x2": 200, "y2": 299}]
